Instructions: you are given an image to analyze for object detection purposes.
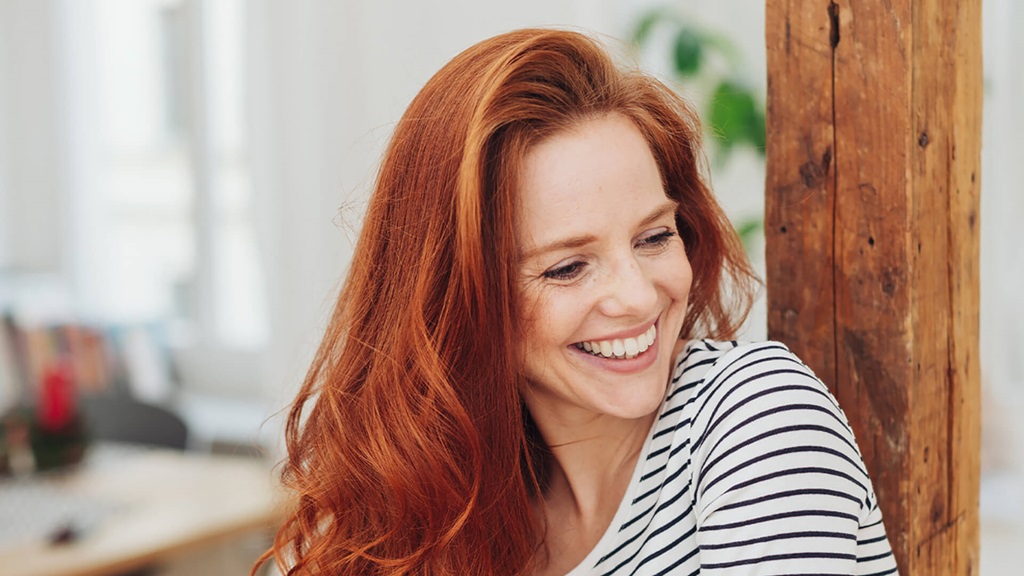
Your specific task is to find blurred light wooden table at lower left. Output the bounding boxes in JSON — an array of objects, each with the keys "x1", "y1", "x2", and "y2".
[{"x1": 0, "y1": 449, "x2": 284, "y2": 576}]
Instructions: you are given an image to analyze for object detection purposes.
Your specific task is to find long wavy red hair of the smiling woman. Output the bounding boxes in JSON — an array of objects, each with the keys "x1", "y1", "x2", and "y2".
[{"x1": 254, "y1": 30, "x2": 756, "y2": 576}]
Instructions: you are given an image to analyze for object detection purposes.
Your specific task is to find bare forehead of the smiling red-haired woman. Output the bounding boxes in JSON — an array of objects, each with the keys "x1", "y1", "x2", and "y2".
[{"x1": 517, "y1": 114, "x2": 666, "y2": 248}]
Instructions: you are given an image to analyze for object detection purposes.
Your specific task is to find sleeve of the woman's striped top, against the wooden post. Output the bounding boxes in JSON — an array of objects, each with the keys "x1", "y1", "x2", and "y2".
[{"x1": 691, "y1": 342, "x2": 896, "y2": 575}]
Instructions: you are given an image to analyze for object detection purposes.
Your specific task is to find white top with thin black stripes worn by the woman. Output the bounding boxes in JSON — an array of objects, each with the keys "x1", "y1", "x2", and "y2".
[{"x1": 569, "y1": 340, "x2": 896, "y2": 576}]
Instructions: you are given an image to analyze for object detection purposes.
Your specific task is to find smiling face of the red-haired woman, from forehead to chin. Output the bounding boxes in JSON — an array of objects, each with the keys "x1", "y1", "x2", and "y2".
[{"x1": 517, "y1": 114, "x2": 691, "y2": 426}]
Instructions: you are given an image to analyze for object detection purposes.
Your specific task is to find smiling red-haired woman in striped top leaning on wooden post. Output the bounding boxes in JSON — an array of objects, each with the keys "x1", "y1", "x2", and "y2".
[{"x1": 256, "y1": 30, "x2": 895, "y2": 575}]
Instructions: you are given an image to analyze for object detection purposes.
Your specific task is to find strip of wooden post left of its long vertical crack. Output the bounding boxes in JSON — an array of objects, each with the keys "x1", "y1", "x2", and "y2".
[{"x1": 765, "y1": 0, "x2": 836, "y2": 392}]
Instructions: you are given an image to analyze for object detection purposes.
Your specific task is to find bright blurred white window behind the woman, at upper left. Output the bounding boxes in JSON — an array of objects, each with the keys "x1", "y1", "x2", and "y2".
[{"x1": 91, "y1": 0, "x2": 267, "y2": 349}]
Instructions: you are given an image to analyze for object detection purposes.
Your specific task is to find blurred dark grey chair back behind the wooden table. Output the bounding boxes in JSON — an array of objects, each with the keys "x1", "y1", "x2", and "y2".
[{"x1": 80, "y1": 395, "x2": 188, "y2": 450}]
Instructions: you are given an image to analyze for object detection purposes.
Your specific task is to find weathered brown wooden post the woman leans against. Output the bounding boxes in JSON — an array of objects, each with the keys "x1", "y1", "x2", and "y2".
[{"x1": 765, "y1": 0, "x2": 982, "y2": 575}]
